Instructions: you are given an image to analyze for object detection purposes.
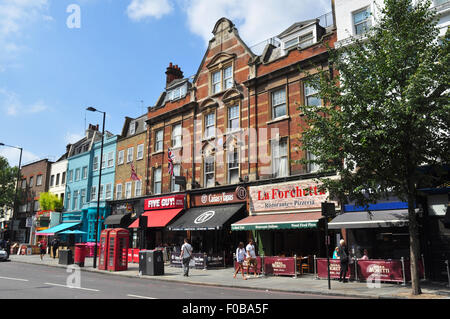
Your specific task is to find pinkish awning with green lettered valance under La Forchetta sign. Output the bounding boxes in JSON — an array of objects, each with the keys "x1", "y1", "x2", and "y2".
[{"x1": 231, "y1": 212, "x2": 322, "y2": 230}]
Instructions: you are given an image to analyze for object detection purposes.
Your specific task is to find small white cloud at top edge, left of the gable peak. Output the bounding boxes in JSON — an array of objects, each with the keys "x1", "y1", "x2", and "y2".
[{"x1": 127, "y1": 0, "x2": 173, "y2": 21}]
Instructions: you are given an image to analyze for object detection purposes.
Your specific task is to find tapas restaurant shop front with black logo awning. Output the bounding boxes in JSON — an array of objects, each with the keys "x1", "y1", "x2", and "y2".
[{"x1": 167, "y1": 186, "x2": 247, "y2": 268}]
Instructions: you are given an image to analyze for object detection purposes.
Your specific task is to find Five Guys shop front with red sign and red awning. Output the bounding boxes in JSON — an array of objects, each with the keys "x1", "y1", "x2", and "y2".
[{"x1": 128, "y1": 194, "x2": 186, "y2": 249}]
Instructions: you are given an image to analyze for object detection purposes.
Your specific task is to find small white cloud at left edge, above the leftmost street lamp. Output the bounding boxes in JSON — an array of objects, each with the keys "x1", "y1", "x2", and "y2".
[{"x1": 0, "y1": 88, "x2": 49, "y2": 116}]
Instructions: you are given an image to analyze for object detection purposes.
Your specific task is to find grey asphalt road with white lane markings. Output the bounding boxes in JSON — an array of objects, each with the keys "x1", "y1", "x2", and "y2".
[{"x1": 0, "y1": 262, "x2": 348, "y2": 300}]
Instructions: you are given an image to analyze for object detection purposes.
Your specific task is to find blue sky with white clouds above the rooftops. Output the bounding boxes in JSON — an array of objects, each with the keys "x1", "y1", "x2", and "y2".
[{"x1": 0, "y1": 0, "x2": 331, "y2": 169}]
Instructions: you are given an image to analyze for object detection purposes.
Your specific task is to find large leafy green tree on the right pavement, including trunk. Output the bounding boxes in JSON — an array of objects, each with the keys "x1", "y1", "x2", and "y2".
[{"x1": 299, "y1": 0, "x2": 450, "y2": 295}]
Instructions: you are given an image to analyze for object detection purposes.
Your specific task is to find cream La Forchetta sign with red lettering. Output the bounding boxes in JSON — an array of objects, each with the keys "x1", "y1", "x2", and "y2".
[{"x1": 249, "y1": 180, "x2": 337, "y2": 213}]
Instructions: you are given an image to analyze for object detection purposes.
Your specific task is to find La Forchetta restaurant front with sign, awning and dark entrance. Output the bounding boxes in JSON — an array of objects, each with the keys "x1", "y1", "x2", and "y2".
[{"x1": 231, "y1": 180, "x2": 339, "y2": 272}]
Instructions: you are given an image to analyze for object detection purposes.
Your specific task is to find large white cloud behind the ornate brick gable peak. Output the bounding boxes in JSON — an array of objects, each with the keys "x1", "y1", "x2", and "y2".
[{"x1": 181, "y1": 0, "x2": 331, "y2": 46}]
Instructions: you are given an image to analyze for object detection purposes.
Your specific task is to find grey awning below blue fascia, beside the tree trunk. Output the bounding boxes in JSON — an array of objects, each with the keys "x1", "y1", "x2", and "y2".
[{"x1": 328, "y1": 209, "x2": 408, "y2": 229}]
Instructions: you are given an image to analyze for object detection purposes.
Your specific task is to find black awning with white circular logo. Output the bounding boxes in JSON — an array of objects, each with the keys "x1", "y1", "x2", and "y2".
[{"x1": 167, "y1": 204, "x2": 244, "y2": 231}]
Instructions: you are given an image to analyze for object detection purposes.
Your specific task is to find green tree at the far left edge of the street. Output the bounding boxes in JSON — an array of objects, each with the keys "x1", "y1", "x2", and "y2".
[{"x1": 0, "y1": 156, "x2": 18, "y2": 210}]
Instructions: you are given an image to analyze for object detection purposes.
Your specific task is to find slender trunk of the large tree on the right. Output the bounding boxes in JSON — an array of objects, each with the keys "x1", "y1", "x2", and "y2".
[{"x1": 408, "y1": 192, "x2": 422, "y2": 295}]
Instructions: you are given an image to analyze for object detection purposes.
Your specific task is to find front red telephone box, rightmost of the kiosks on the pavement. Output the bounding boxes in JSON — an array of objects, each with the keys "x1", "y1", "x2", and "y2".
[{"x1": 107, "y1": 228, "x2": 130, "y2": 271}]
